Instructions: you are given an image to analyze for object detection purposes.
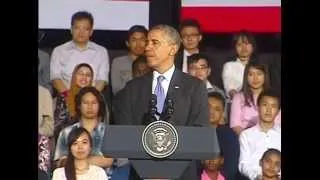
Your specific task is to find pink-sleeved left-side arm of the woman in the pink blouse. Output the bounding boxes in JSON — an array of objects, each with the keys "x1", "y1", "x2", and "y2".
[{"x1": 230, "y1": 94, "x2": 243, "y2": 135}]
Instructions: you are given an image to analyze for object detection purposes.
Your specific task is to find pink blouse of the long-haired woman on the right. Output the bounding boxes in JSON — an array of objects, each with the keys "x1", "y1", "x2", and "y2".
[{"x1": 230, "y1": 92, "x2": 281, "y2": 129}]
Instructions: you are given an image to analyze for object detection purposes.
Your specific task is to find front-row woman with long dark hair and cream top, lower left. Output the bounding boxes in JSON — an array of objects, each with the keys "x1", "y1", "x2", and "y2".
[{"x1": 52, "y1": 127, "x2": 108, "y2": 180}]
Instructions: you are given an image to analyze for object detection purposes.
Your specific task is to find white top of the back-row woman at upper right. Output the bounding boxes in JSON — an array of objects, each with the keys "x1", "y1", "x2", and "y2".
[{"x1": 222, "y1": 58, "x2": 246, "y2": 97}]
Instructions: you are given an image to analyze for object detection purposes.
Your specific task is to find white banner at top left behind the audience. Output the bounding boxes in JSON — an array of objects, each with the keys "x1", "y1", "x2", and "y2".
[{"x1": 39, "y1": 0, "x2": 149, "y2": 30}]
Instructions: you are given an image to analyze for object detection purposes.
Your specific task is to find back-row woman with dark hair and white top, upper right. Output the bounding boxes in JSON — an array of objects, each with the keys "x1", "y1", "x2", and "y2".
[{"x1": 222, "y1": 31, "x2": 256, "y2": 98}]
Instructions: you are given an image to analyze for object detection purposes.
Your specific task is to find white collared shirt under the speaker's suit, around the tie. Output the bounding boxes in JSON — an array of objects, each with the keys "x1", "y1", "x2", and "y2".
[{"x1": 152, "y1": 65, "x2": 175, "y2": 100}]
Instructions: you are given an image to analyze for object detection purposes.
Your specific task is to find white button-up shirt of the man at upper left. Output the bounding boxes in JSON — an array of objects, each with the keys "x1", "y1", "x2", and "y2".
[{"x1": 50, "y1": 41, "x2": 109, "y2": 89}]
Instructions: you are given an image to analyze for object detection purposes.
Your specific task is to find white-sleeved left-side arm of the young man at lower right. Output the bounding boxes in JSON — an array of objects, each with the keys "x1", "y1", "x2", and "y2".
[{"x1": 239, "y1": 133, "x2": 261, "y2": 179}]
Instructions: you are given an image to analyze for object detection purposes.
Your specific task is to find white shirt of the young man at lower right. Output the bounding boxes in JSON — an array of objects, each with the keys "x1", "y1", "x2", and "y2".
[{"x1": 239, "y1": 123, "x2": 281, "y2": 180}]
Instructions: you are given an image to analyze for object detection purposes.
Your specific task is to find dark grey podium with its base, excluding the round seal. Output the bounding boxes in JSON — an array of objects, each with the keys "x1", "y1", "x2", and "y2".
[{"x1": 102, "y1": 125, "x2": 220, "y2": 179}]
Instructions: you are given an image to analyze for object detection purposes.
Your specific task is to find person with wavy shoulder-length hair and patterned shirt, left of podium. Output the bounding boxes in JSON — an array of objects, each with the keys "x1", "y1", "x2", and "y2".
[{"x1": 54, "y1": 87, "x2": 113, "y2": 176}]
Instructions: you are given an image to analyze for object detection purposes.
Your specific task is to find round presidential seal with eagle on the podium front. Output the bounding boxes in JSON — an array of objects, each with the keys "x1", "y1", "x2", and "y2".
[{"x1": 142, "y1": 121, "x2": 178, "y2": 158}]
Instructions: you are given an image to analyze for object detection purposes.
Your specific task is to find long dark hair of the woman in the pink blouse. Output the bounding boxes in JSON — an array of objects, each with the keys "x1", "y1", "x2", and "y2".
[{"x1": 242, "y1": 59, "x2": 270, "y2": 107}]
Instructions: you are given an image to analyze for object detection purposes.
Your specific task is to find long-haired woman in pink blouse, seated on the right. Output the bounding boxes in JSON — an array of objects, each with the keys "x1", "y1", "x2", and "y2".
[{"x1": 230, "y1": 59, "x2": 281, "y2": 135}]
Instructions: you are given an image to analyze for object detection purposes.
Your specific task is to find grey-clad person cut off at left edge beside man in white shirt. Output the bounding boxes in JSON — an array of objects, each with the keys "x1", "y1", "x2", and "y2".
[{"x1": 38, "y1": 49, "x2": 53, "y2": 94}]
